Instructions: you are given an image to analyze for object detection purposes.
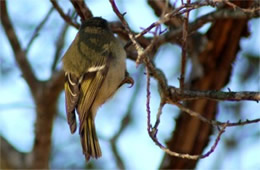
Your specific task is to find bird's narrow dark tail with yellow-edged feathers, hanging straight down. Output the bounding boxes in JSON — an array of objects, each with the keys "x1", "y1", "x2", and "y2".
[{"x1": 80, "y1": 116, "x2": 102, "y2": 161}]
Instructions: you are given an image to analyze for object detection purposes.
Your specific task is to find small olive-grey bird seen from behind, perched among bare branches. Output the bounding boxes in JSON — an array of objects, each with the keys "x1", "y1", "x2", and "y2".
[{"x1": 62, "y1": 17, "x2": 134, "y2": 161}]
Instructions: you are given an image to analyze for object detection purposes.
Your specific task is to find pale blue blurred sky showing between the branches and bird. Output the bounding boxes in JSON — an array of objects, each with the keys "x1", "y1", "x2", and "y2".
[{"x1": 0, "y1": 0, "x2": 260, "y2": 169}]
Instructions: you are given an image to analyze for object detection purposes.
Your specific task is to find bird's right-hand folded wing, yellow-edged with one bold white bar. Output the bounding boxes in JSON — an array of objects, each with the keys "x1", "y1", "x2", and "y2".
[{"x1": 77, "y1": 52, "x2": 110, "y2": 132}]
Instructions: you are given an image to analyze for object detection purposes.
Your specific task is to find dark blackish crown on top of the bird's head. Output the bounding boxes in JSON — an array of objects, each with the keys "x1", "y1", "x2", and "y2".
[{"x1": 80, "y1": 17, "x2": 108, "y2": 29}]
